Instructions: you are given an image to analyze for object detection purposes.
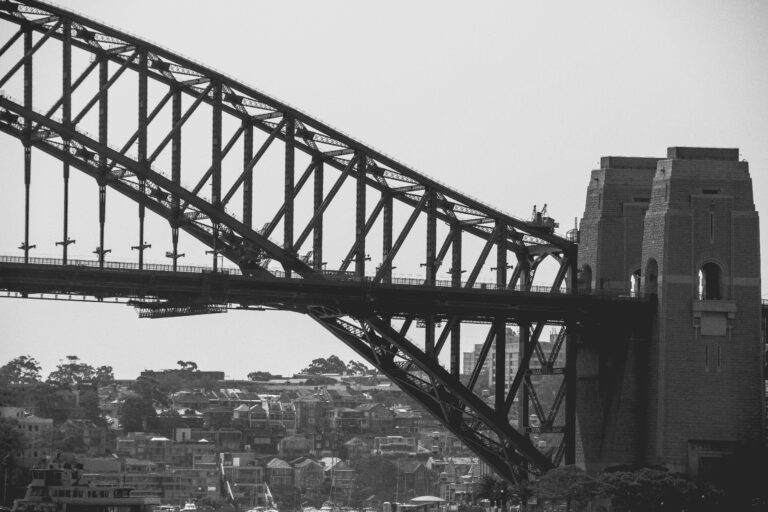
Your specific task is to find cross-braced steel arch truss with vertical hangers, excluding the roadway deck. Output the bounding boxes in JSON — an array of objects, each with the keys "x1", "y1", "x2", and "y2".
[{"x1": 0, "y1": 0, "x2": 592, "y2": 481}]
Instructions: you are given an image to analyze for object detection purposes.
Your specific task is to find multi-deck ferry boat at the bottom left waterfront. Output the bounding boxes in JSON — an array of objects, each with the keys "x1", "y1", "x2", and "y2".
[{"x1": 12, "y1": 463, "x2": 160, "y2": 512}]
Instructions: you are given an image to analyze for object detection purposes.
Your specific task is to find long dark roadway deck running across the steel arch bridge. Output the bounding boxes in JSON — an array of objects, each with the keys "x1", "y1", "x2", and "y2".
[{"x1": 0, "y1": 256, "x2": 653, "y2": 323}]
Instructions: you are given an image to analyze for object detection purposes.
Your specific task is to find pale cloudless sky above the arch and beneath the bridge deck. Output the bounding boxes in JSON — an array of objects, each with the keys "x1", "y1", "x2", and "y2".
[{"x1": 0, "y1": 0, "x2": 768, "y2": 378}]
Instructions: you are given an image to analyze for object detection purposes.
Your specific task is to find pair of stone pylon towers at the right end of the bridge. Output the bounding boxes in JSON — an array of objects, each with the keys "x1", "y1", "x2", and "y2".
[{"x1": 577, "y1": 147, "x2": 764, "y2": 475}]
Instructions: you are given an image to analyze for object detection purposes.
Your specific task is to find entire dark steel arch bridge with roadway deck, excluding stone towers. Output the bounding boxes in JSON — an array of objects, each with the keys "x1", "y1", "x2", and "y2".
[{"x1": 0, "y1": 0, "x2": 651, "y2": 481}]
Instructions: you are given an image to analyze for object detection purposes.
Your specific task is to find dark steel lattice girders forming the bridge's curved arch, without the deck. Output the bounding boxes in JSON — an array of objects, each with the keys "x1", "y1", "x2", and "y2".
[{"x1": 0, "y1": 0, "x2": 640, "y2": 479}]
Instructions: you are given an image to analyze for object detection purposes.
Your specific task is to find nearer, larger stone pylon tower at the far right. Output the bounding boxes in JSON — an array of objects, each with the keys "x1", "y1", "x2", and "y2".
[{"x1": 642, "y1": 147, "x2": 764, "y2": 474}]
